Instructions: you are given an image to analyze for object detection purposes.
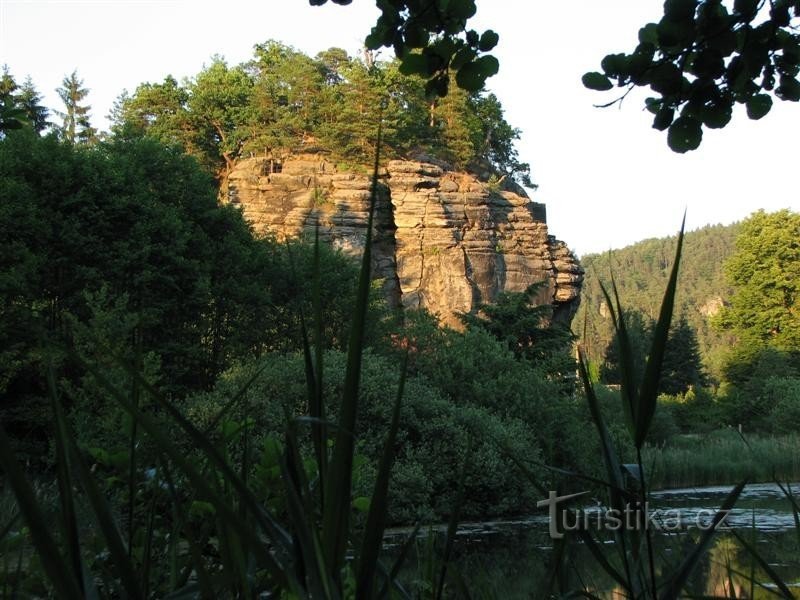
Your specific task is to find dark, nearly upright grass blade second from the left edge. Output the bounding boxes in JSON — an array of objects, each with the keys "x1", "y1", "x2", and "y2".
[{"x1": 47, "y1": 366, "x2": 86, "y2": 592}]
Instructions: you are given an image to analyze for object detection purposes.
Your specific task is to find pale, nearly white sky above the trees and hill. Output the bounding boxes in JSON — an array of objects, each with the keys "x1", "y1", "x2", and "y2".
[{"x1": 0, "y1": 0, "x2": 800, "y2": 254}]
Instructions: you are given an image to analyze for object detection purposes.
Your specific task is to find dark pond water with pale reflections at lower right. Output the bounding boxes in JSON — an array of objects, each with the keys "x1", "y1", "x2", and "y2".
[{"x1": 387, "y1": 484, "x2": 800, "y2": 600}]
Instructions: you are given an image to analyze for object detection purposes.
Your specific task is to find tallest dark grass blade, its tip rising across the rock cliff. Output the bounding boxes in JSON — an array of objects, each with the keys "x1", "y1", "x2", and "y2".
[{"x1": 322, "y1": 116, "x2": 382, "y2": 577}]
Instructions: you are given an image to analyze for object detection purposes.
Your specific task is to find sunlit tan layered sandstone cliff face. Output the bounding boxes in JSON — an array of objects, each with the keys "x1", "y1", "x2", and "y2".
[{"x1": 226, "y1": 155, "x2": 583, "y2": 325}]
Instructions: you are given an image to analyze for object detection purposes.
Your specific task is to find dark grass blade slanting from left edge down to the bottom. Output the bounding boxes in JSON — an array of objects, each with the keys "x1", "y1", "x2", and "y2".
[{"x1": 0, "y1": 425, "x2": 81, "y2": 598}]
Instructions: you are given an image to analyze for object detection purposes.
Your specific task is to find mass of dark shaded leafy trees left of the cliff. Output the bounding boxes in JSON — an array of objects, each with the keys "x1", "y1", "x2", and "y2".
[{"x1": 0, "y1": 131, "x2": 362, "y2": 454}]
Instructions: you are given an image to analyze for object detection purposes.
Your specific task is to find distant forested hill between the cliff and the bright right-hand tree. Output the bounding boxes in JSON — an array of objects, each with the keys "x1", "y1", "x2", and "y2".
[{"x1": 573, "y1": 223, "x2": 739, "y2": 378}]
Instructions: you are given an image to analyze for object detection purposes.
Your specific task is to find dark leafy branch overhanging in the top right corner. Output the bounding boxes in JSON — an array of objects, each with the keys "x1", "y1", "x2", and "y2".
[{"x1": 583, "y1": 0, "x2": 800, "y2": 153}]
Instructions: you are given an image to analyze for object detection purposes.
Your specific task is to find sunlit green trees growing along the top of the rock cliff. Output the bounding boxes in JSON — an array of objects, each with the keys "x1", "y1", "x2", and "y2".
[{"x1": 108, "y1": 41, "x2": 530, "y2": 183}]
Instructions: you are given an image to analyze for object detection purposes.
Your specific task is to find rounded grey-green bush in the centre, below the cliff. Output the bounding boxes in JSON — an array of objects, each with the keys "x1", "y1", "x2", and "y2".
[{"x1": 186, "y1": 350, "x2": 544, "y2": 523}]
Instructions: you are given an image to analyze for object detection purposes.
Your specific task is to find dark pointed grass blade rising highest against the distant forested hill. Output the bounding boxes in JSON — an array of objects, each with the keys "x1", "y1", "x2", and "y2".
[{"x1": 634, "y1": 214, "x2": 686, "y2": 449}]
